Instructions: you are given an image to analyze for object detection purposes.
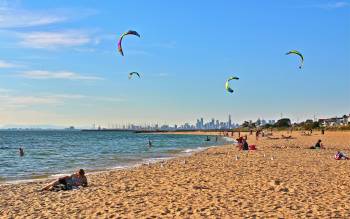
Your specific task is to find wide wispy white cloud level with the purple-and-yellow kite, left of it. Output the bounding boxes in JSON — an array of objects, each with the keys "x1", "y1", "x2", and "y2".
[{"x1": 19, "y1": 31, "x2": 93, "y2": 49}]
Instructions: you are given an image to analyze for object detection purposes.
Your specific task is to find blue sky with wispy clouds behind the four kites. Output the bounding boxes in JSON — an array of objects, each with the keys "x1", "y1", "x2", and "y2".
[{"x1": 0, "y1": 0, "x2": 350, "y2": 127}]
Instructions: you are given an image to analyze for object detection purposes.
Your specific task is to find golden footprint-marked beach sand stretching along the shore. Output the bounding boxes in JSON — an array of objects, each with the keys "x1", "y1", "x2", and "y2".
[{"x1": 0, "y1": 132, "x2": 350, "y2": 218}]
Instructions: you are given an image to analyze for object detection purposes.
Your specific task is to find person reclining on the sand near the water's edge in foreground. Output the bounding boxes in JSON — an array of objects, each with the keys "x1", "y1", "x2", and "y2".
[{"x1": 42, "y1": 169, "x2": 88, "y2": 191}]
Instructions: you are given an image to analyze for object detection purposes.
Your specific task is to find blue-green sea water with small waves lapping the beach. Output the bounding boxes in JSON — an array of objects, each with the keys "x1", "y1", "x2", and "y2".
[{"x1": 0, "y1": 131, "x2": 228, "y2": 183}]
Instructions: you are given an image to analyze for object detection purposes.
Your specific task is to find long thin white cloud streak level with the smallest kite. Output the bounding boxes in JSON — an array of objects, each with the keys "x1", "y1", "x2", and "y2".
[{"x1": 19, "y1": 71, "x2": 103, "y2": 80}]
